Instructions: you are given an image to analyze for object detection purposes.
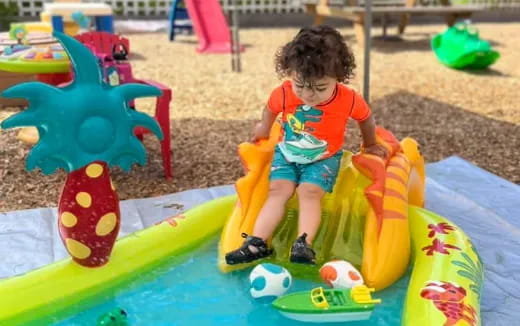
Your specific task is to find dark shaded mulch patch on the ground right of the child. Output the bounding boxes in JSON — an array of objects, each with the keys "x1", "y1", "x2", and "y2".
[{"x1": 372, "y1": 92, "x2": 520, "y2": 184}]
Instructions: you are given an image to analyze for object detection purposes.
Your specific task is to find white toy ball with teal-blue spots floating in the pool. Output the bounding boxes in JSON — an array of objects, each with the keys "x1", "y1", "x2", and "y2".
[{"x1": 249, "y1": 263, "x2": 292, "y2": 299}]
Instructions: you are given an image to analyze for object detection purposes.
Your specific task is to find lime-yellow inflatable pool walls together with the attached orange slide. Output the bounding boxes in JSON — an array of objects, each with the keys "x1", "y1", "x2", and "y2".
[{"x1": 0, "y1": 33, "x2": 483, "y2": 326}]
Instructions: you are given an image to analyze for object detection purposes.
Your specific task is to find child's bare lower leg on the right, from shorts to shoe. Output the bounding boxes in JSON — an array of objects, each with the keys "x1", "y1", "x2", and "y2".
[{"x1": 297, "y1": 183, "x2": 325, "y2": 244}]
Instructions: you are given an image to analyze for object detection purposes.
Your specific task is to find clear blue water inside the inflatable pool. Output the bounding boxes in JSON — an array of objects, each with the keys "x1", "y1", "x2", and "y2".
[{"x1": 54, "y1": 239, "x2": 408, "y2": 326}]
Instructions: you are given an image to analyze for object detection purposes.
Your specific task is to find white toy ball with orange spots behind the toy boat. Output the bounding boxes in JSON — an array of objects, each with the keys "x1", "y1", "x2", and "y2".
[{"x1": 320, "y1": 260, "x2": 363, "y2": 289}]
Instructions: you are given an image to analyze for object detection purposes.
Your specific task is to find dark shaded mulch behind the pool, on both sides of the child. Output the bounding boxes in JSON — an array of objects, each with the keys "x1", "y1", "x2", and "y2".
[{"x1": 0, "y1": 92, "x2": 520, "y2": 211}]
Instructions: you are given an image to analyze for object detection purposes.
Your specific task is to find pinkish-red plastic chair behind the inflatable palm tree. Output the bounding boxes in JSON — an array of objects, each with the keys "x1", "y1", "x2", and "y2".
[{"x1": 76, "y1": 32, "x2": 172, "y2": 179}]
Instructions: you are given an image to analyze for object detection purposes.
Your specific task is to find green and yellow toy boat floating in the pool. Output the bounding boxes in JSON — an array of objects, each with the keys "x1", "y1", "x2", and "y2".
[{"x1": 272, "y1": 285, "x2": 381, "y2": 323}]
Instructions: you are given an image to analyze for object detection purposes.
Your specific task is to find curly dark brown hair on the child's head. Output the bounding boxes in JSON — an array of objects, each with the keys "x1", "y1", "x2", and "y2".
[{"x1": 275, "y1": 25, "x2": 356, "y2": 85}]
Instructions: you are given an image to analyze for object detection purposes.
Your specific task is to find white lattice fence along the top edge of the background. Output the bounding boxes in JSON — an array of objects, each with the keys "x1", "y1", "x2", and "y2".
[{"x1": 0, "y1": 0, "x2": 520, "y2": 17}]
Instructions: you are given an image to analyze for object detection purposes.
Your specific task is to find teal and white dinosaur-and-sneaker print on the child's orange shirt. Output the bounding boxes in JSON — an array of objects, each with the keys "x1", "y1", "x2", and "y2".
[{"x1": 279, "y1": 105, "x2": 328, "y2": 164}]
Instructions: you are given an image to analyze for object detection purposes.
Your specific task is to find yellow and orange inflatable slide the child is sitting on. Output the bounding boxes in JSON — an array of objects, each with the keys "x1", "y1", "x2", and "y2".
[{"x1": 219, "y1": 125, "x2": 424, "y2": 290}]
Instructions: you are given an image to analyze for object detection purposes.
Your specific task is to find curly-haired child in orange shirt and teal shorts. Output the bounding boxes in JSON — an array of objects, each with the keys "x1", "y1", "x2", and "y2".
[{"x1": 226, "y1": 25, "x2": 386, "y2": 265}]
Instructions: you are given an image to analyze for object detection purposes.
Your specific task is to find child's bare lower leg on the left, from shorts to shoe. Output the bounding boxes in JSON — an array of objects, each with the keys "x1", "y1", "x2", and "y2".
[{"x1": 253, "y1": 179, "x2": 296, "y2": 241}]
